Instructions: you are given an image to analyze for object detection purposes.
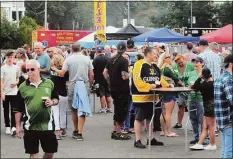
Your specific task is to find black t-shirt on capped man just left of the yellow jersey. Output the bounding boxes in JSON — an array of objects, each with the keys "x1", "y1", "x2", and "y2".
[{"x1": 106, "y1": 56, "x2": 129, "y2": 93}]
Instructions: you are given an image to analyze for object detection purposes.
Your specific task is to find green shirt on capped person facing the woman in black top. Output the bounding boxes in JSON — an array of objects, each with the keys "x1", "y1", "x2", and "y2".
[{"x1": 188, "y1": 71, "x2": 202, "y2": 102}]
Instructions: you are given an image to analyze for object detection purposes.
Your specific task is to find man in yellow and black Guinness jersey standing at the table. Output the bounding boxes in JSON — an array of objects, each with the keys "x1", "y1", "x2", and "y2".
[{"x1": 131, "y1": 47, "x2": 169, "y2": 149}]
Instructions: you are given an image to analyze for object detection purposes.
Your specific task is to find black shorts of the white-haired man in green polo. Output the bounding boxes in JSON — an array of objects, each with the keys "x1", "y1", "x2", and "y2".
[{"x1": 24, "y1": 130, "x2": 58, "y2": 154}]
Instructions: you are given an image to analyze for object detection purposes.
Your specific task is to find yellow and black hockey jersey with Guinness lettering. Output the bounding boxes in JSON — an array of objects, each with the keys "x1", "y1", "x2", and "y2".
[{"x1": 131, "y1": 60, "x2": 169, "y2": 103}]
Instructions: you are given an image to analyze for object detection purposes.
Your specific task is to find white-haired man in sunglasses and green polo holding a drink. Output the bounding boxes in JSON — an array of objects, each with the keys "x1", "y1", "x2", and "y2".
[{"x1": 15, "y1": 60, "x2": 58, "y2": 158}]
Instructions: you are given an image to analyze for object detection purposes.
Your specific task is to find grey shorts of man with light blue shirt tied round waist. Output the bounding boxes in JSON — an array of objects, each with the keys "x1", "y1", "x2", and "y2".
[{"x1": 67, "y1": 83, "x2": 90, "y2": 110}]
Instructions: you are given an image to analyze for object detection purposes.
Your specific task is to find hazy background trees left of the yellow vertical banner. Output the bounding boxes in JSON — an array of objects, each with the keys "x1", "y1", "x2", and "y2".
[{"x1": 25, "y1": 1, "x2": 93, "y2": 30}]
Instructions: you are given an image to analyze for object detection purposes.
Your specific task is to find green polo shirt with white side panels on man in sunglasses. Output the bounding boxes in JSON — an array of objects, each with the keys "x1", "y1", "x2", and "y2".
[{"x1": 16, "y1": 79, "x2": 58, "y2": 131}]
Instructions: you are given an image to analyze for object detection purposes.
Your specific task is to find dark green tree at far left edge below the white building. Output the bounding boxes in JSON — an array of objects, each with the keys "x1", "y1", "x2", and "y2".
[{"x1": 0, "y1": 16, "x2": 23, "y2": 49}]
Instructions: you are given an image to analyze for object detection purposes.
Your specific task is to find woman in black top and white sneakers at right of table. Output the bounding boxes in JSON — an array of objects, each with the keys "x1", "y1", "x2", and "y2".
[{"x1": 190, "y1": 68, "x2": 217, "y2": 150}]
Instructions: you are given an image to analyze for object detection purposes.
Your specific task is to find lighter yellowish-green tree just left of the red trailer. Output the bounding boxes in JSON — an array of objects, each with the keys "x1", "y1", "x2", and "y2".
[{"x1": 19, "y1": 16, "x2": 41, "y2": 44}]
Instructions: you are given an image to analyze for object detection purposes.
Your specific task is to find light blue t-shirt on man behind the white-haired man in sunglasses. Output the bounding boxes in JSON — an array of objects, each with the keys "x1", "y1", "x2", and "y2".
[{"x1": 36, "y1": 53, "x2": 50, "y2": 79}]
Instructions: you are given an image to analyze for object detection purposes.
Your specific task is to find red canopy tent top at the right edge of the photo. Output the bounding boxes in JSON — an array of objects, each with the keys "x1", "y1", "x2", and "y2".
[{"x1": 200, "y1": 24, "x2": 232, "y2": 44}]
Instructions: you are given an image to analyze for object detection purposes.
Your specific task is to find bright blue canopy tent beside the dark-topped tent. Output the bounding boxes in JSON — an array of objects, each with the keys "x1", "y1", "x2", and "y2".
[{"x1": 133, "y1": 28, "x2": 200, "y2": 42}]
